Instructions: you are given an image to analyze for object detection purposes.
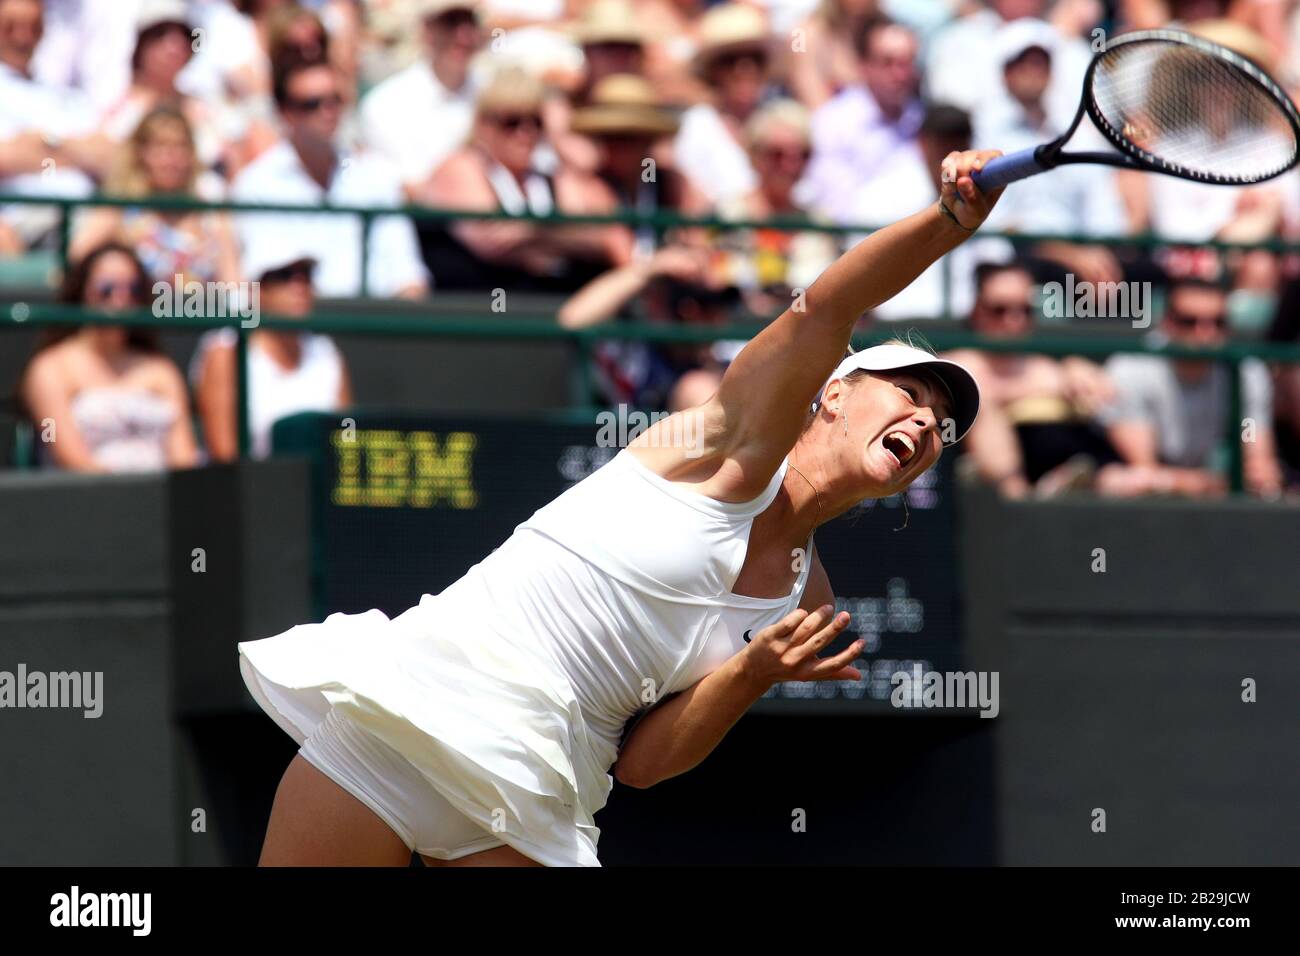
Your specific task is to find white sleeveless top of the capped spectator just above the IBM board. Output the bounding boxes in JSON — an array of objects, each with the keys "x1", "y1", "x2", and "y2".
[{"x1": 190, "y1": 329, "x2": 343, "y2": 458}]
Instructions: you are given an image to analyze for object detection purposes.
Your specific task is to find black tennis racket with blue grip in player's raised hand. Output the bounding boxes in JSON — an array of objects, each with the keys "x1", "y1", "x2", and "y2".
[{"x1": 971, "y1": 30, "x2": 1300, "y2": 191}]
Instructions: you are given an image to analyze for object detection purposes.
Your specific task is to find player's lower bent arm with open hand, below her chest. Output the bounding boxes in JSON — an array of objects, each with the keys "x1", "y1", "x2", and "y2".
[{"x1": 614, "y1": 605, "x2": 862, "y2": 787}]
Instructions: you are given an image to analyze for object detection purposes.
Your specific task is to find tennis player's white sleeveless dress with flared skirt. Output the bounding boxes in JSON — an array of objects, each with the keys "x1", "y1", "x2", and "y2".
[{"x1": 239, "y1": 450, "x2": 811, "y2": 866}]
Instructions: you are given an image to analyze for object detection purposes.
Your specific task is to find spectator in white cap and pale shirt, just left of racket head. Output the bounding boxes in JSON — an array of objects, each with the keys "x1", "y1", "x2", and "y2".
[{"x1": 975, "y1": 17, "x2": 1127, "y2": 284}]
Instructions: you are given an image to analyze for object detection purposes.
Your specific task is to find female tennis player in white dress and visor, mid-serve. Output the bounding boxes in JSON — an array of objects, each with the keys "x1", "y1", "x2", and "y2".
[{"x1": 239, "y1": 152, "x2": 1000, "y2": 866}]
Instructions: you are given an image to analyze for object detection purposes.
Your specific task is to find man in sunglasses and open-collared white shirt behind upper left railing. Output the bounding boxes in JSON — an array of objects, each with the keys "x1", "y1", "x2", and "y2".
[{"x1": 231, "y1": 55, "x2": 429, "y2": 298}]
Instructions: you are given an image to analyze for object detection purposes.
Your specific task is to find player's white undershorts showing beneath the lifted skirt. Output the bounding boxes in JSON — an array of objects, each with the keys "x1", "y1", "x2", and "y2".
[{"x1": 298, "y1": 708, "x2": 506, "y2": 860}]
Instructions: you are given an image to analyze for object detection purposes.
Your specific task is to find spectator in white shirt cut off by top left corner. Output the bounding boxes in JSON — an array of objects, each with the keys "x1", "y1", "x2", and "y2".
[{"x1": 0, "y1": 0, "x2": 112, "y2": 246}]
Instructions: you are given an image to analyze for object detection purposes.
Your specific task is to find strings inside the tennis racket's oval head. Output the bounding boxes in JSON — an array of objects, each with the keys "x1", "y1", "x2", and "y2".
[{"x1": 1092, "y1": 40, "x2": 1297, "y2": 183}]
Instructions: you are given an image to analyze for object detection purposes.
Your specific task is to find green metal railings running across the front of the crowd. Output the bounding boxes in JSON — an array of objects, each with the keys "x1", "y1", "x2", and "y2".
[{"x1": 0, "y1": 195, "x2": 1300, "y2": 490}]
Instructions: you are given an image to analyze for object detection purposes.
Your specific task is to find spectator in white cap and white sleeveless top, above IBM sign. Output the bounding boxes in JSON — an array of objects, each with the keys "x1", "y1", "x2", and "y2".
[{"x1": 190, "y1": 239, "x2": 352, "y2": 462}]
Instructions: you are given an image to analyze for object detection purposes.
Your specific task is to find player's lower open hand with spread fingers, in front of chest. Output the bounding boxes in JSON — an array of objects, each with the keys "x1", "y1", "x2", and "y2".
[{"x1": 741, "y1": 605, "x2": 866, "y2": 684}]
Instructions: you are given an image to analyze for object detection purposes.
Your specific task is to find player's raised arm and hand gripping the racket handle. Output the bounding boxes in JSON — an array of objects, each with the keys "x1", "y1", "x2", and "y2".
[{"x1": 709, "y1": 150, "x2": 1001, "y2": 501}]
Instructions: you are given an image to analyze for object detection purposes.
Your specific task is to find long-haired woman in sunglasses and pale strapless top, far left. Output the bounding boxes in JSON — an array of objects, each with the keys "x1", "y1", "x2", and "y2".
[{"x1": 18, "y1": 243, "x2": 199, "y2": 472}]
